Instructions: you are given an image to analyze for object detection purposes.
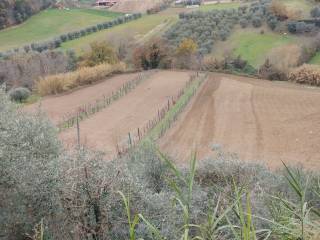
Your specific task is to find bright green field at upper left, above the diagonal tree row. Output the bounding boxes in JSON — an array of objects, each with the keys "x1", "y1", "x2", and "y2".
[{"x1": 0, "y1": 9, "x2": 120, "y2": 51}]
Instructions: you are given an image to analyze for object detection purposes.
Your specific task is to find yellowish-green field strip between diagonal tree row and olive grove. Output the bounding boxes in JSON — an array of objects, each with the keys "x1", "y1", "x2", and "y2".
[{"x1": 61, "y1": 9, "x2": 178, "y2": 54}]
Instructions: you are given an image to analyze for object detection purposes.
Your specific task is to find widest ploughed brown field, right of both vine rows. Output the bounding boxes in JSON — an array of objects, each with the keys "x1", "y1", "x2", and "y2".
[{"x1": 159, "y1": 74, "x2": 320, "y2": 169}]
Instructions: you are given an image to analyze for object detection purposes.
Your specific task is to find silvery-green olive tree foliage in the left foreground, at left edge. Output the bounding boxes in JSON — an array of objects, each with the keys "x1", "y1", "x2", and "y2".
[{"x1": 0, "y1": 90, "x2": 61, "y2": 239}]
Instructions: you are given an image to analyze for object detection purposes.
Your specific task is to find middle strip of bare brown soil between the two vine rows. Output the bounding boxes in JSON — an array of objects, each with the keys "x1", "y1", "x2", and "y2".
[{"x1": 60, "y1": 71, "x2": 190, "y2": 157}]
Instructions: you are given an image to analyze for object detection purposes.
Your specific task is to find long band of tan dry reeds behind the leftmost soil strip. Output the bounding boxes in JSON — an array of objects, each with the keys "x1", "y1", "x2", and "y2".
[{"x1": 35, "y1": 63, "x2": 126, "y2": 96}]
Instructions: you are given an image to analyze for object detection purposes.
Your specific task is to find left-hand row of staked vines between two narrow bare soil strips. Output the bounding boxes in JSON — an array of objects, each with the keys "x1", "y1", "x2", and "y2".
[{"x1": 57, "y1": 71, "x2": 156, "y2": 132}]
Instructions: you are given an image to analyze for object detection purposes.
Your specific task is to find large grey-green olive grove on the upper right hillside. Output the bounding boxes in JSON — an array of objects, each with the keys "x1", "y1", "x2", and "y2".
[{"x1": 165, "y1": 0, "x2": 278, "y2": 55}]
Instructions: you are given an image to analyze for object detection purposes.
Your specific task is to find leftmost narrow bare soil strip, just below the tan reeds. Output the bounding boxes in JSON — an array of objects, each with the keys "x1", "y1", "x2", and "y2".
[{"x1": 25, "y1": 73, "x2": 138, "y2": 124}]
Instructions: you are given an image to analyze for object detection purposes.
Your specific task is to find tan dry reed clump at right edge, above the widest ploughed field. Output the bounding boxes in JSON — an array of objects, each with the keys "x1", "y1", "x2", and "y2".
[{"x1": 289, "y1": 64, "x2": 320, "y2": 86}]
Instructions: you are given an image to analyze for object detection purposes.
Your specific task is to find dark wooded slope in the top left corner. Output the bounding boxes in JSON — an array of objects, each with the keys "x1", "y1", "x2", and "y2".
[{"x1": 0, "y1": 0, "x2": 55, "y2": 29}]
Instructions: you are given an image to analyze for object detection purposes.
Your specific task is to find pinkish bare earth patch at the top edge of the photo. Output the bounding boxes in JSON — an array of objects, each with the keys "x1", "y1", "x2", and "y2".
[{"x1": 111, "y1": 0, "x2": 163, "y2": 13}]
